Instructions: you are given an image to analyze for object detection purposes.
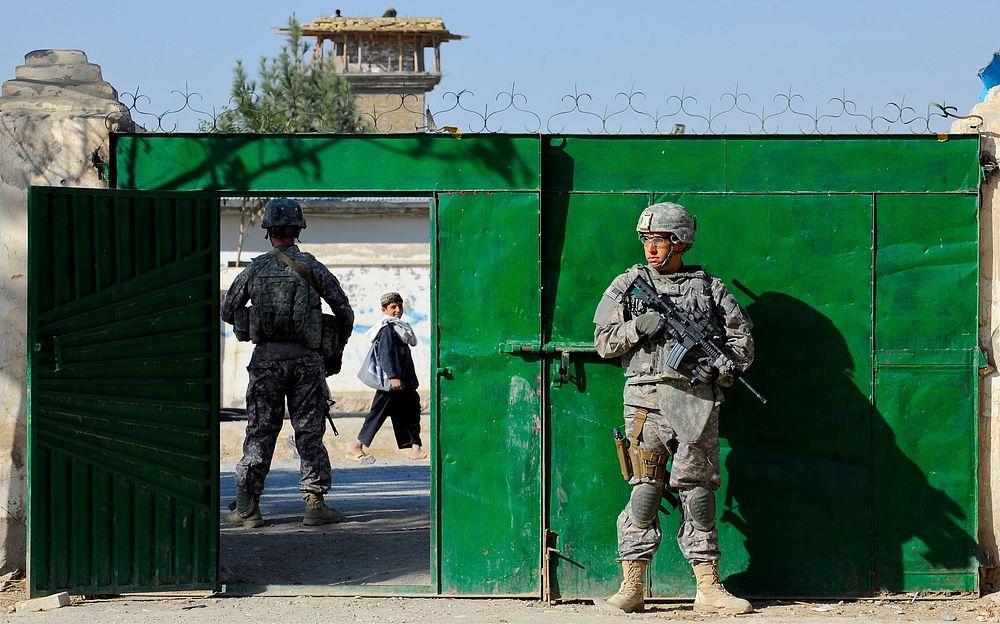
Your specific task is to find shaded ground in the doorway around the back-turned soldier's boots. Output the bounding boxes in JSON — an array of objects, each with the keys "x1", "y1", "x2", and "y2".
[{"x1": 220, "y1": 460, "x2": 431, "y2": 586}]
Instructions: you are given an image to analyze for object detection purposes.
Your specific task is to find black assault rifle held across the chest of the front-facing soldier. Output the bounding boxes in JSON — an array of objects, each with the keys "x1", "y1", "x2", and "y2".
[{"x1": 629, "y1": 275, "x2": 767, "y2": 405}]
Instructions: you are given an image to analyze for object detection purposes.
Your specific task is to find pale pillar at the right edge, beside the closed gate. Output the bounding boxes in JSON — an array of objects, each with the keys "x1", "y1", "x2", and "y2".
[{"x1": 951, "y1": 87, "x2": 1000, "y2": 593}]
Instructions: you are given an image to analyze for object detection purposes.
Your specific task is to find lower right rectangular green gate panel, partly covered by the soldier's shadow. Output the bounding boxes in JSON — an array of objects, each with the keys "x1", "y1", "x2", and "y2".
[{"x1": 872, "y1": 368, "x2": 979, "y2": 592}]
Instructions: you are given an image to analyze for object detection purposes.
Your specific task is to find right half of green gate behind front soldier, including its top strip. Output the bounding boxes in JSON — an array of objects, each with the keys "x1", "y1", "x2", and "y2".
[{"x1": 541, "y1": 137, "x2": 979, "y2": 598}]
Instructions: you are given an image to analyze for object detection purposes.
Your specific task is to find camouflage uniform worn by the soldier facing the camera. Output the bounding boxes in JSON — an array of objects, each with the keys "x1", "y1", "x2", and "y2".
[{"x1": 594, "y1": 264, "x2": 753, "y2": 561}]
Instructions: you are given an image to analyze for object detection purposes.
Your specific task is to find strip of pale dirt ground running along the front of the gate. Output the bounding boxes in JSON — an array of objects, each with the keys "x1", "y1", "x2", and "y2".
[{"x1": 0, "y1": 592, "x2": 1000, "y2": 624}]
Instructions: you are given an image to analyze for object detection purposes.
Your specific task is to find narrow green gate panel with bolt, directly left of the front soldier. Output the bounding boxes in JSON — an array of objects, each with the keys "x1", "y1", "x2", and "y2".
[{"x1": 542, "y1": 193, "x2": 649, "y2": 598}]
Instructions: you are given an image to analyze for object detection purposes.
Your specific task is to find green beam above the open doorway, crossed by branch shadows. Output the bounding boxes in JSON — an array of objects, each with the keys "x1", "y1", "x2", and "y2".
[{"x1": 112, "y1": 134, "x2": 539, "y2": 192}]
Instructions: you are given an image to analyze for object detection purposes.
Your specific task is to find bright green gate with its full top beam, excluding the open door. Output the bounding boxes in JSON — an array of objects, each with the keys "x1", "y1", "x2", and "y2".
[{"x1": 23, "y1": 135, "x2": 980, "y2": 598}]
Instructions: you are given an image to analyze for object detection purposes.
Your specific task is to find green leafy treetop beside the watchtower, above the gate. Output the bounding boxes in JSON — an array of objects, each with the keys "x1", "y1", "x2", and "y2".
[{"x1": 211, "y1": 14, "x2": 362, "y2": 133}]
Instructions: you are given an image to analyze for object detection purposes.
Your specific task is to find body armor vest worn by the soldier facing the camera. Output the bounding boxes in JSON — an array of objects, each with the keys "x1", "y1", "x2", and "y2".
[{"x1": 622, "y1": 265, "x2": 721, "y2": 383}]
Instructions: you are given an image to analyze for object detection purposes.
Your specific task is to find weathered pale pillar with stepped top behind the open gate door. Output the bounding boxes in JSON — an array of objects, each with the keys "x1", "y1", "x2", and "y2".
[{"x1": 0, "y1": 50, "x2": 133, "y2": 572}]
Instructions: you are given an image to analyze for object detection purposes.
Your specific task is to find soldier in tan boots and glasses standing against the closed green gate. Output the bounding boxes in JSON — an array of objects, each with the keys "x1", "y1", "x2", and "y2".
[{"x1": 594, "y1": 203, "x2": 753, "y2": 614}]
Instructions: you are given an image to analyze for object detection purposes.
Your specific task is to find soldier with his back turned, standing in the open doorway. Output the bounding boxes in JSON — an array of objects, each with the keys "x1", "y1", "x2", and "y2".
[{"x1": 221, "y1": 198, "x2": 354, "y2": 527}]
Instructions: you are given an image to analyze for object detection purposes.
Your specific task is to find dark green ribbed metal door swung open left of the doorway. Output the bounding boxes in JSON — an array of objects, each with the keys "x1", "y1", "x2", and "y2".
[{"x1": 28, "y1": 188, "x2": 219, "y2": 595}]
